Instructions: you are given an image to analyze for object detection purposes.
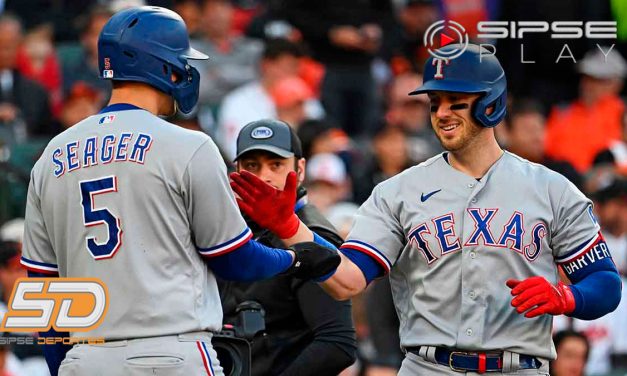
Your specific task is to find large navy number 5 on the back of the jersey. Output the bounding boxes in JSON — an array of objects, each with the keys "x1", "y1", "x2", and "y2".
[{"x1": 79, "y1": 176, "x2": 122, "y2": 260}]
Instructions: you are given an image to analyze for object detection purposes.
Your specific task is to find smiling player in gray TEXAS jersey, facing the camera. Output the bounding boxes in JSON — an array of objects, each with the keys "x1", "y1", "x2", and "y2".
[{"x1": 231, "y1": 45, "x2": 621, "y2": 375}]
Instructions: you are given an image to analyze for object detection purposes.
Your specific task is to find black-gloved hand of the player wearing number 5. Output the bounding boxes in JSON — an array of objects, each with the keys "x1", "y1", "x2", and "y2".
[{"x1": 282, "y1": 242, "x2": 342, "y2": 279}]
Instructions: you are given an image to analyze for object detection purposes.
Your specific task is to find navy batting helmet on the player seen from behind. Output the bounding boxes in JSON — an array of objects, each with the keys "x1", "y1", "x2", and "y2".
[{"x1": 98, "y1": 7, "x2": 209, "y2": 114}]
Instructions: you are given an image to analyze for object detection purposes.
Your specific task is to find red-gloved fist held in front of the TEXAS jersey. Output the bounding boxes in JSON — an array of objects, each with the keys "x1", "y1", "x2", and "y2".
[{"x1": 506, "y1": 276, "x2": 575, "y2": 318}]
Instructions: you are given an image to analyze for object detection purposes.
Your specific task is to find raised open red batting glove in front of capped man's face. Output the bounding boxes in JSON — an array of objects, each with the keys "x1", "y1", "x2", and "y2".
[{"x1": 230, "y1": 171, "x2": 300, "y2": 239}]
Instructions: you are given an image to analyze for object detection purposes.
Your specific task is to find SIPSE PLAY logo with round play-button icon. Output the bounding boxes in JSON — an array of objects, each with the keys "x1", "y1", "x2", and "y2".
[{"x1": 423, "y1": 20, "x2": 617, "y2": 64}]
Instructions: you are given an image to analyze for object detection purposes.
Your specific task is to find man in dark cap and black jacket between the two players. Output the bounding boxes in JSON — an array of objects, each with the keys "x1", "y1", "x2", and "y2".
[{"x1": 219, "y1": 120, "x2": 356, "y2": 376}]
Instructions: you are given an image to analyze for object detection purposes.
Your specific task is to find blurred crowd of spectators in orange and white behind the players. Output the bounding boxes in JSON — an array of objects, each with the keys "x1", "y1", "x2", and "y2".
[{"x1": 0, "y1": 0, "x2": 627, "y2": 376}]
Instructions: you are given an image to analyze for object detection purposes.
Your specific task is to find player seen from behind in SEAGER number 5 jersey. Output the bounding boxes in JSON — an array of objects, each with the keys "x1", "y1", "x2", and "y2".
[{"x1": 22, "y1": 7, "x2": 340, "y2": 375}]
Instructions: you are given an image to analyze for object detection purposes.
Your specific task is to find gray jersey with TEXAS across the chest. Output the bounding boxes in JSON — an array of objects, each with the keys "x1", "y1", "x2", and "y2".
[{"x1": 343, "y1": 152, "x2": 609, "y2": 358}]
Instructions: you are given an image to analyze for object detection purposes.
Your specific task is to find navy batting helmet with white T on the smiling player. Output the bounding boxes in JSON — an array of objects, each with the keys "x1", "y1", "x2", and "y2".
[{"x1": 409, "y1": 44, "x2": 507, "y2": 128}]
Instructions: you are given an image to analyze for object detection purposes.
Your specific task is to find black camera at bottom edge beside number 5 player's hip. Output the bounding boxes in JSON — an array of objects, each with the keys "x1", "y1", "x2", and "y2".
[{"x1": 211, "y1": 300, "x2": 266, "y2": 376}]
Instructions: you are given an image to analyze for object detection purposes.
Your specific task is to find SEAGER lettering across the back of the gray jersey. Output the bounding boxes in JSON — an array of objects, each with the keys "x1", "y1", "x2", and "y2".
[{"x1": 52, "y1": 132, "x2": 152, "y2": 177}]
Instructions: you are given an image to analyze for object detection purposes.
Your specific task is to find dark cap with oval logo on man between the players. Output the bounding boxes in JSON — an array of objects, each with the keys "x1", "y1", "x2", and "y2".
[{"x1": 235, "y1": 119, "x2": 303, "y2": 161}]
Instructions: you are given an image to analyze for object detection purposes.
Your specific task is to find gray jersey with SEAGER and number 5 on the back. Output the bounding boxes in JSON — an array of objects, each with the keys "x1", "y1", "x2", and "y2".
[{"x1": 22, "y1": 104, "x2": 251, "y2": 339}]
